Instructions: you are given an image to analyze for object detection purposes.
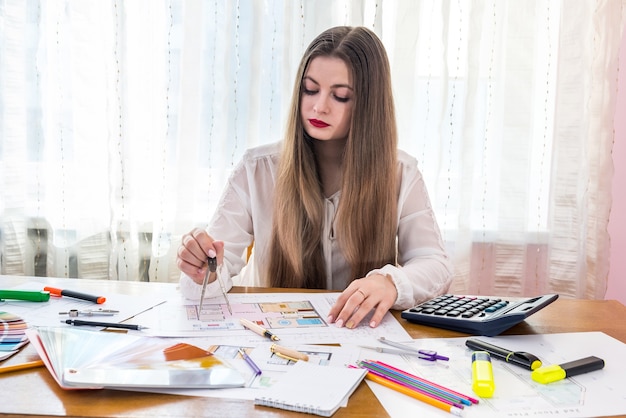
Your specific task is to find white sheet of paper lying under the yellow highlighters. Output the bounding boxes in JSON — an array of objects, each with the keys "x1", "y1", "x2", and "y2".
[{"x1": 348, "y1": 332, "x2": 626, "y2": 418}]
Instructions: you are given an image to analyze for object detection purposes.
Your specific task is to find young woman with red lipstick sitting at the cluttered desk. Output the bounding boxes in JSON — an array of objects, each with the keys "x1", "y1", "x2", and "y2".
[{"x1": 178, "y1": 27, "x2": 451, "y2": 328}]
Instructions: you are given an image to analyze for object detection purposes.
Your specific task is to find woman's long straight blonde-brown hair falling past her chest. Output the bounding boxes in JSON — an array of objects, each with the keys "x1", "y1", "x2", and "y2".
[{"x1": 265, "y1": 26, "x2": 398, "y2": 289}]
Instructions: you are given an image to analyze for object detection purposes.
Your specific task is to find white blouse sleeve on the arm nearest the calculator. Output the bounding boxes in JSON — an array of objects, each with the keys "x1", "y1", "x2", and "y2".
[{"x1": 368, "y1": 154, "x2": 452, "y2": 309}]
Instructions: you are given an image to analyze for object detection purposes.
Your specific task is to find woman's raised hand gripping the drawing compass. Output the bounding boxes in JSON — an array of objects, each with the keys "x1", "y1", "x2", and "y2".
[{"x1": 176, "y1": 228, "x2": 224, "y2": 284}]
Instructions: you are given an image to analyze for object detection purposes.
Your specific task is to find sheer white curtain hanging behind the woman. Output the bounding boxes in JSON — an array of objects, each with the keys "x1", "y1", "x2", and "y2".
[{"x1": 0, "y1": 0, "x2": 626, "y2": 298}]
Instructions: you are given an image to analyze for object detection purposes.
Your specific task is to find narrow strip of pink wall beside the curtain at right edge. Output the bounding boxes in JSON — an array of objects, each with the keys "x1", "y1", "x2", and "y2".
[{"x1": 605, "y1": 31, "x2": 626, "y2": 305}]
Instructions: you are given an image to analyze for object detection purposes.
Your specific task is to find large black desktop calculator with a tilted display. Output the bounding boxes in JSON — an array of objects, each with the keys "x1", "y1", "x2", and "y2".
[{"x1": 401, "y1": 294, "x2": 559, "y2": 337}]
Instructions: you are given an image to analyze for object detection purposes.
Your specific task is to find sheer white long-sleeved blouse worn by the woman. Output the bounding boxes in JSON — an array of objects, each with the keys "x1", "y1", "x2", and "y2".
[{"x1": 180, "y1": 143, "x2": 452, "y2": 309}]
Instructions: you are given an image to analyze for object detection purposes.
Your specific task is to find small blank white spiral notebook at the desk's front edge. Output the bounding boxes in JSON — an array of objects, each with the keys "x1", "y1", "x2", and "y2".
[{"x1": 254, "y1": 361, "x2": 367, "y2": 417}]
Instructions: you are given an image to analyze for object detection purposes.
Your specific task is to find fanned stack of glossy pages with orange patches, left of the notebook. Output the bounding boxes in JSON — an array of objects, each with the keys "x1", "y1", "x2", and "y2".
[{"x1": 26, "y1": 327, "x2": 245, "y2": 389}]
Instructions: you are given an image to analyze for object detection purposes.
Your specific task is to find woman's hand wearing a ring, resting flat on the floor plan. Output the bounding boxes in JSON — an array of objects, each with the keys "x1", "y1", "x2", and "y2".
[{"x1": 328, "y1": 274, "x2": 398, "y2": 328}]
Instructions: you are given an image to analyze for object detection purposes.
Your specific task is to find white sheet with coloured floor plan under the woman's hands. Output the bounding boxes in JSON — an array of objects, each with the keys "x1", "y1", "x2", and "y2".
[{"x1": 143, "y1": 293, "x2": 411, "y2": 346}]
